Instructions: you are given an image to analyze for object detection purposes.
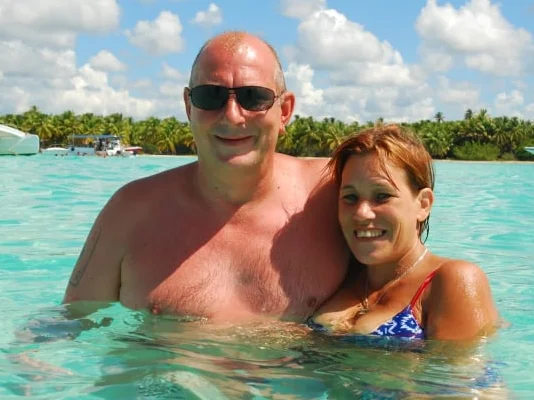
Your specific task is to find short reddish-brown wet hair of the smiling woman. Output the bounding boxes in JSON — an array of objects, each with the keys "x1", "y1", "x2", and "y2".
[{"x1": 328, "y1": 124, "x2": 434, "y2": 242}]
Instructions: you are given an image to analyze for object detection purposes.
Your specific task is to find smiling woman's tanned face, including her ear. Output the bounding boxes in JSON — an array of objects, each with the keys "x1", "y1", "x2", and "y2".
[{"x1": 338, "y1": 152, "x2": 433, "y2": 265}]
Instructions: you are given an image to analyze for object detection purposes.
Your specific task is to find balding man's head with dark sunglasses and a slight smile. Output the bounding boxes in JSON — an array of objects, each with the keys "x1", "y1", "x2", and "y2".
[{"x1": 184, "y1": 32, "x2": 295, "y2": 165}]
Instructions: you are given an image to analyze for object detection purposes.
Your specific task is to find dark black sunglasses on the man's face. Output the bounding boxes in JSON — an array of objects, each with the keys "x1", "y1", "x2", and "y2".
[{"x1": 189, "y1": 85, "x2": 282, "y2": 111}]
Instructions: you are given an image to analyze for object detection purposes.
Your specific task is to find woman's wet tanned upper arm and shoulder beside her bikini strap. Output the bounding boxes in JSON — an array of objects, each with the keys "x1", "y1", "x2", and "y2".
[{"x1": 425, "y1": 260, "x2": 498, "y2": 340}]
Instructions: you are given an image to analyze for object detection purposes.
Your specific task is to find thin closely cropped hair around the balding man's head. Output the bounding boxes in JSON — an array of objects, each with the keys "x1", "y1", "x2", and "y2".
[{"x1": 189, "y1": 31, "x2": 286, "y2": 93}]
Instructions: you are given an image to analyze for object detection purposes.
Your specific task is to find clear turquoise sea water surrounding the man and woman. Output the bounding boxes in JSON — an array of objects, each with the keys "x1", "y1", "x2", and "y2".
[{"x1": 0, "y1": 156, "x2": 534, "y2": 399}]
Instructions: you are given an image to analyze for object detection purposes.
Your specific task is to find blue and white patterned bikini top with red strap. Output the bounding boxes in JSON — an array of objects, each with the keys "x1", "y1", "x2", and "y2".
[{"x1": 308, "y1": 270, "x2": 437, "y2": 339}]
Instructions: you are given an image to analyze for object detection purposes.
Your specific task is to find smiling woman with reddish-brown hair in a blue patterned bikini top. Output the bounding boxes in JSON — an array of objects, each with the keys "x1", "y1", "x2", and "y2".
[{"x1": 309, "y1": 125, "x2": 498, "y2": 340}]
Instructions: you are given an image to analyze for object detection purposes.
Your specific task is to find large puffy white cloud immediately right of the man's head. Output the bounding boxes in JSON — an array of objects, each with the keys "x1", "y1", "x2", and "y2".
[{"x1": 286, "y1": 9, "x2": 434, "y2": 122}]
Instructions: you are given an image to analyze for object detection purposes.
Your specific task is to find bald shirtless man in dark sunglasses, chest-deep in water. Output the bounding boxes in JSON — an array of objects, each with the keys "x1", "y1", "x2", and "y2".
[{"x1": 64, "y1": 32, "x2": 348, "y2": 321}]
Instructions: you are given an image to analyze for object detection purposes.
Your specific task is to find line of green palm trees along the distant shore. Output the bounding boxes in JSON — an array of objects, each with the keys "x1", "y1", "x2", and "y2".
[{"x1": 0, "y1": 106, "x2": 534, "y2": 161}]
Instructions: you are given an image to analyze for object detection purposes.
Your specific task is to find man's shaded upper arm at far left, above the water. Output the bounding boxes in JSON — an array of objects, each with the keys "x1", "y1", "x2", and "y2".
[{"x1": 63, "y1": 189, "x2": 129, "y2": 303}]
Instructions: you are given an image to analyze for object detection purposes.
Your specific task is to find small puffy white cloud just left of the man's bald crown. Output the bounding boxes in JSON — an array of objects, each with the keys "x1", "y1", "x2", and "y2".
[{"x1": 125, "y1": 11, "x2": 184, "y2": 55}]
